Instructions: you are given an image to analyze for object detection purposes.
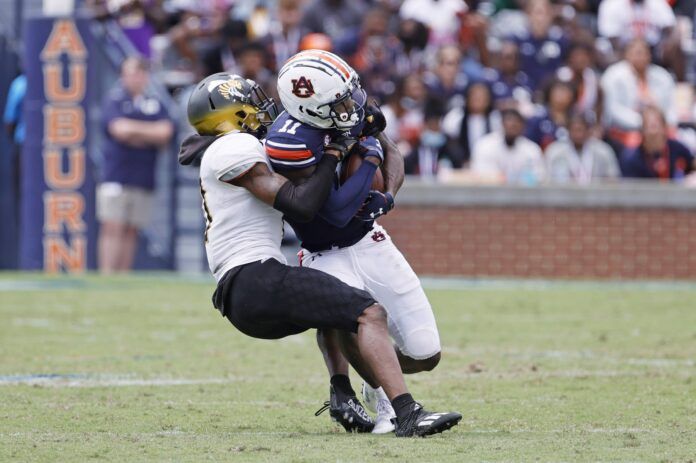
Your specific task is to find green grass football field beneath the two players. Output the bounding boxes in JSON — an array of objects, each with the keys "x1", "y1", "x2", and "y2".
[{"x1": 0, "y1": 275, "x2": 696, "y2": 462}]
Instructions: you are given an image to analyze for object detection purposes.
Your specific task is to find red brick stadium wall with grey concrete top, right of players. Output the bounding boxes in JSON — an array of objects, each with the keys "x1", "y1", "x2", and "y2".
[{"x1": 380, "y1": 182, "x2": 696, "y2": 280}]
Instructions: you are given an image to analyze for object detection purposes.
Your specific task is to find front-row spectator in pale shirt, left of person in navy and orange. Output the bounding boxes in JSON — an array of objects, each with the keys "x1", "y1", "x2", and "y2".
[{"x1": 545, "y1": 112, "x2": 620, "y2": 185}]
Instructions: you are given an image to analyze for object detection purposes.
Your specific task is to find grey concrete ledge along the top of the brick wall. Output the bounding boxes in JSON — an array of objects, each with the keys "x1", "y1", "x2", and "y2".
[{"x1": 396, "y1": 179, "x2": 696, "y2": 210}]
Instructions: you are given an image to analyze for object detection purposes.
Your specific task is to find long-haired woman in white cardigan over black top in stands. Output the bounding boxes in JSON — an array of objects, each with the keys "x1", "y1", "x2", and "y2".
[{"x1": 442, "y1": 82, "x2": 500, "y2": 164}]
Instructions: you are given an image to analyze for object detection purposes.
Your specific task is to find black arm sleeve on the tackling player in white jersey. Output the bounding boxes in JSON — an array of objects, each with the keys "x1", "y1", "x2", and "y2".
[{"x1": 273, "y1": 156, "x2": 338, "y2": 222}]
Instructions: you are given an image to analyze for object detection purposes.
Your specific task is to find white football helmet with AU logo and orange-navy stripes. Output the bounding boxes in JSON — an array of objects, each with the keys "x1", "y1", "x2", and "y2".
[{"x1": 278, "y1": 50, "x2": 367, "y2": 130}]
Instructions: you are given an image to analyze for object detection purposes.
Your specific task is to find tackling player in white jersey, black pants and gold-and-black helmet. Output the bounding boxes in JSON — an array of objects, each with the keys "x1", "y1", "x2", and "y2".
[{"x1": 179, "y1": 73, "x2": 461, "y2": 436}]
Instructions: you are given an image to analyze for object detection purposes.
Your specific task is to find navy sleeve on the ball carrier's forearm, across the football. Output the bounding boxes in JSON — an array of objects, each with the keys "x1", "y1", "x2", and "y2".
[{"x1": 319, "y1": 161, "x2": 377, "y2": 228}]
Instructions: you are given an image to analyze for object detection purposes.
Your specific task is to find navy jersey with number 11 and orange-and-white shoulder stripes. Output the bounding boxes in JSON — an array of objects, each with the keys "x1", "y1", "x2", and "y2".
[{"x1": 266, "y1": 112, "x2": 374, "y2": 252}]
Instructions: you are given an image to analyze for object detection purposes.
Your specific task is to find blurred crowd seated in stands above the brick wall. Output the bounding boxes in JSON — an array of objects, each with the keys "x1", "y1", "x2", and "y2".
[{"x1": 92, "y1": 0, "x2": 696, "y2": 185}]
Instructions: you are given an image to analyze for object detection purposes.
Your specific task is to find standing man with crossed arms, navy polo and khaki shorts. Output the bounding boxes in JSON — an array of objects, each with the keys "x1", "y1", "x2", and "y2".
[{"x1": 97, "y1": 57, "x2": 174, "y2": 273}]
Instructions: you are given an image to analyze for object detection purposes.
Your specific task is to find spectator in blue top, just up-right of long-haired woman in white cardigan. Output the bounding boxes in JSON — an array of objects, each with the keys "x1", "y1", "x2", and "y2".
[{"x1": 485, "y1": 41, "x2": 532, "y2": 104}]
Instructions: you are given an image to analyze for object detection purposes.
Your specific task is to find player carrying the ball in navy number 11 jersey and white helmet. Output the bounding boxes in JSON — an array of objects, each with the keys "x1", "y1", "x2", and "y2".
[{"x1": 266, "y1": 50, "x2": 440, "y2": 433}]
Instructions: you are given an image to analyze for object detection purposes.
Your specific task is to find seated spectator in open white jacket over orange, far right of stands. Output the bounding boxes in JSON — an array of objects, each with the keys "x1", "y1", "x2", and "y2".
[{"x1": 601, "y1": 39, "x2": 675, "y2": 147}]
